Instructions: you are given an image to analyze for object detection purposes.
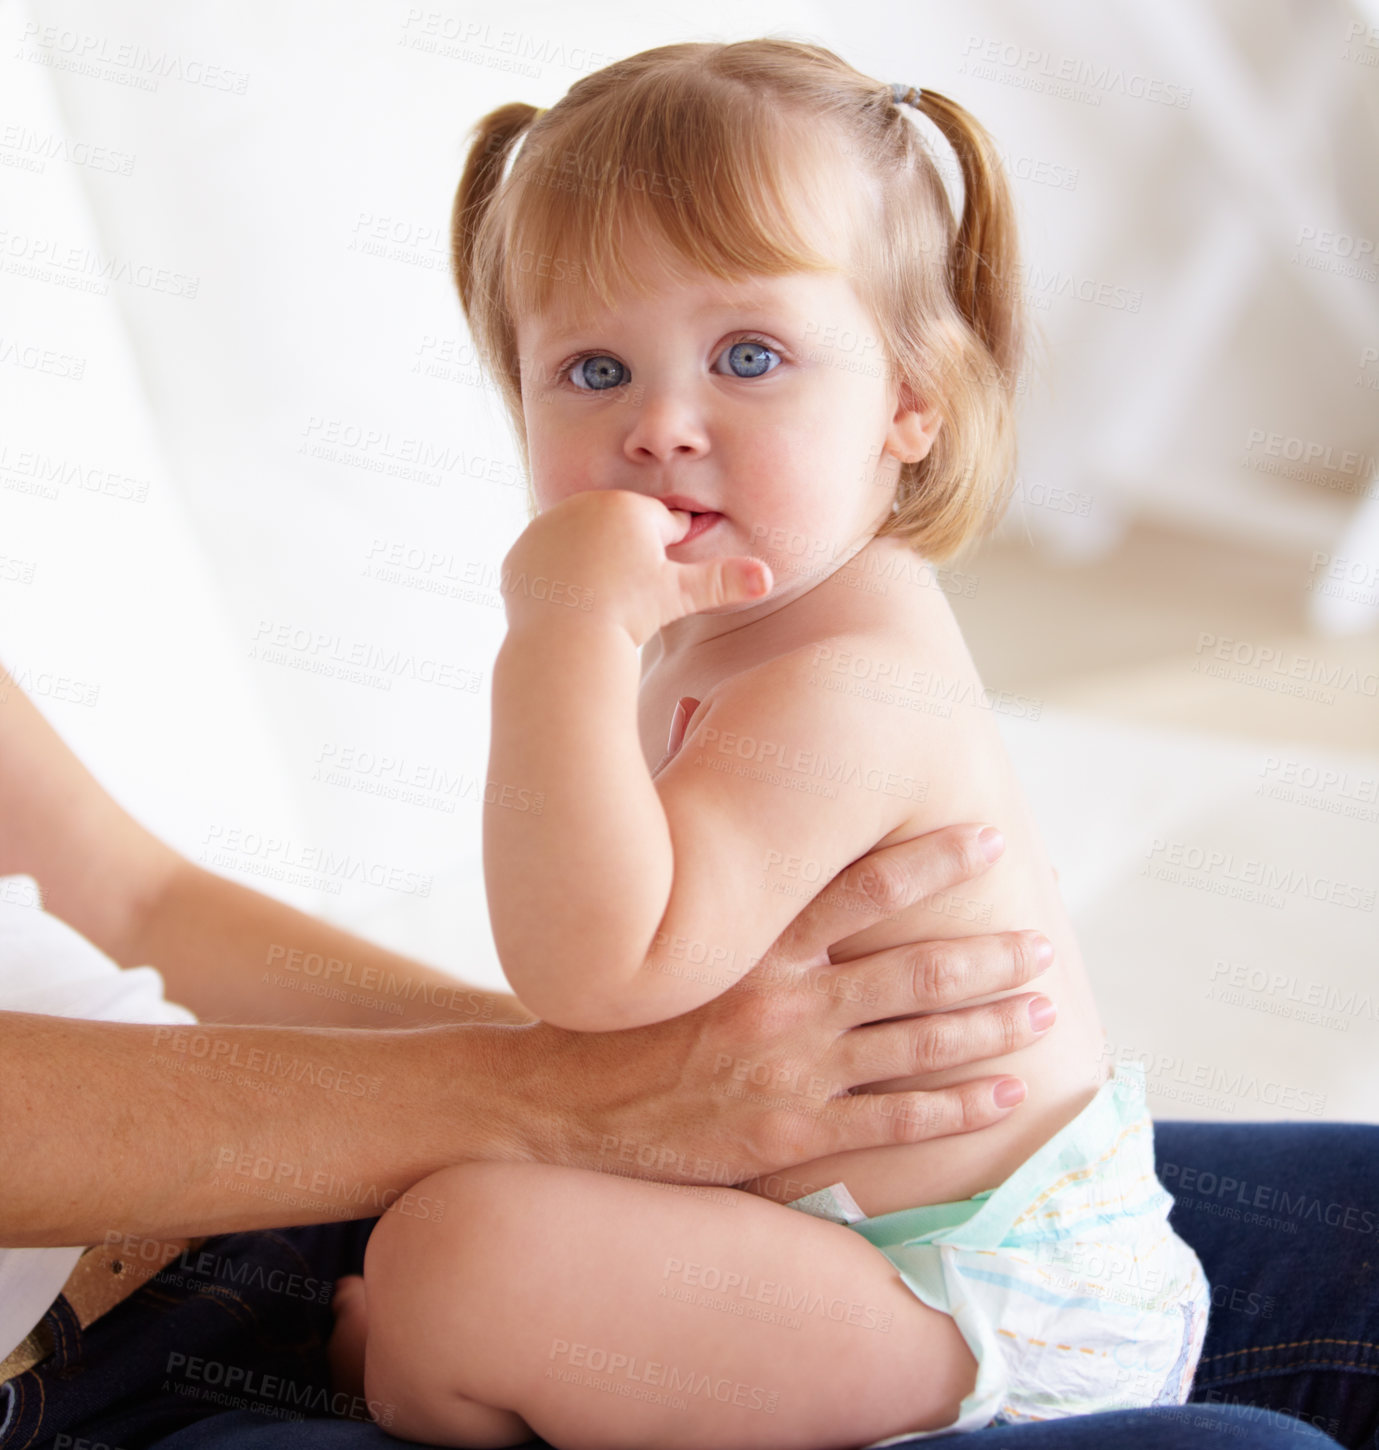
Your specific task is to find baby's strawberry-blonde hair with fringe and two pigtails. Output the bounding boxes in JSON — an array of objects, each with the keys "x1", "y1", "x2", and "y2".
[{"x1": 451, "y1": 38, "x2": 1025, "y2": 560}]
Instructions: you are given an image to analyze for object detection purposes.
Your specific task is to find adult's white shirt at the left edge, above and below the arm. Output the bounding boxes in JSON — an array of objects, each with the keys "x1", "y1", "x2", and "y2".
[{"x1": 0, "y1": 876, "x2": 196, "y2": 1363}]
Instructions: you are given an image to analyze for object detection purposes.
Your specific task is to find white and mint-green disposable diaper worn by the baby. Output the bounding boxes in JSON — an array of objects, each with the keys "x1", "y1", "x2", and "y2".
[{"x1": 789, "y1": 1063, "x2": 1211, "y2": 1450}]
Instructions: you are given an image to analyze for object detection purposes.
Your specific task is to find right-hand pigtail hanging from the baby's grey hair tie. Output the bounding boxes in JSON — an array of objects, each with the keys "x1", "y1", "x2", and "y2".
[{"x1": 919, "y1": 90, "x2": 1024, "y2": 387}]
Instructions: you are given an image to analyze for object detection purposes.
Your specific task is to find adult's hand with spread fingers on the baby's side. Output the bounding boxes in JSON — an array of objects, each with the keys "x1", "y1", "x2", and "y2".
[{"x1": 490, "y1": 825, "x2": 1053, "y2": 1183}]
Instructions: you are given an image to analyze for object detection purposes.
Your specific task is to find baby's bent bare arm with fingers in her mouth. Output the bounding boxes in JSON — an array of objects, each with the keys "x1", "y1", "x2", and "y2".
[{"x1": 484, "y1": 494, "x2": 914, "y2": 1031}]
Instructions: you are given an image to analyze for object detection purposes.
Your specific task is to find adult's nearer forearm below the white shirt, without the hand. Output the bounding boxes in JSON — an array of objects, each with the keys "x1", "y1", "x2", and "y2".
[{"x1": 0, "y1": 1012, "x2": 526, "y2": 1247}]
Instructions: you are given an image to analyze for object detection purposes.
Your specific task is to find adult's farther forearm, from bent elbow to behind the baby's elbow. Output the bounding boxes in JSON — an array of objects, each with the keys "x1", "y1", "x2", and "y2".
[{"x1": 133, "y1": 861, "x2": 531, "y2": 1028}]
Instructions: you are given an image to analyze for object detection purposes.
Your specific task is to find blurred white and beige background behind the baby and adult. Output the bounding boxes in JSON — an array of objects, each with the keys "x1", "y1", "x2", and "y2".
[{"x1": 0, "y1": 0, "x2": 1379, "y2": 1121}]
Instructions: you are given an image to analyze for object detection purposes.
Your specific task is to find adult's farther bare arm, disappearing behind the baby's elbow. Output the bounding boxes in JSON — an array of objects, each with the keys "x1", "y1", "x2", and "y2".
[{"x1": 0, "y1": 668, "x2": 532, "y2": 1028}]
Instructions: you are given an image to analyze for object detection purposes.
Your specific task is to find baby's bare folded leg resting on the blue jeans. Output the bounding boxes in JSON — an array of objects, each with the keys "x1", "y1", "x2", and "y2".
[{"x1": 364, "y1": 1163, "x2": 976, "y2": 1450}]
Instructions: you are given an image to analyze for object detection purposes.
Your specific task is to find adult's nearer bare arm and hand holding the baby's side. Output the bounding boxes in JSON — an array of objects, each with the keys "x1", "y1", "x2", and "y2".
[{"x1": 0, "y1": 827, "x2": 1047, "y2": 1247}]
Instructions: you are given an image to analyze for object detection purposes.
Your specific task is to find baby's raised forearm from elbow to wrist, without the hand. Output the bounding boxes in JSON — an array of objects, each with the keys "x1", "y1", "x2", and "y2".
[{"x1": 483, "y1": 617, "x2": 674, "y2": 1028}]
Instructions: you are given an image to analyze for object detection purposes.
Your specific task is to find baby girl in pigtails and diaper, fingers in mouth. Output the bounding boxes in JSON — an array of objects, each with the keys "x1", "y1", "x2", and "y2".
[{"x1": 332, "y1": 39, "x2": 1209, "y2": 1450}]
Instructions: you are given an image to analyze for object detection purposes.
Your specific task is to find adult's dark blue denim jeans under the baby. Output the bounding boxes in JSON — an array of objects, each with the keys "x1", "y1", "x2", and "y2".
[{"x1": 0, "y1": 1122, "x2": 1379, "y2": 1450}]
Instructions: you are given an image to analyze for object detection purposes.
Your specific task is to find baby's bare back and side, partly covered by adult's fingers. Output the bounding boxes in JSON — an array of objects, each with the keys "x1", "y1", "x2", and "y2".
[{"x1": 644, "y1": 539, "x2": 1109, "y2": 1217}]
